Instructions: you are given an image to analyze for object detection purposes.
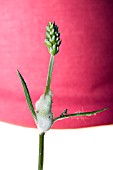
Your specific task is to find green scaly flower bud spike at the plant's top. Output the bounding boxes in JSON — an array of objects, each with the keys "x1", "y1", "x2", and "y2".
[{"x1": 45, "y1": 22, "x2": 61, "y2": 56}]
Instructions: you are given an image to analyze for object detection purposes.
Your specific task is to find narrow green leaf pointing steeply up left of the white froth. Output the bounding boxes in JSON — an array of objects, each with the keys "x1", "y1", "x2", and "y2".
[{"x1": 17, "y1": 70, "x2": 37, "y2": 121}]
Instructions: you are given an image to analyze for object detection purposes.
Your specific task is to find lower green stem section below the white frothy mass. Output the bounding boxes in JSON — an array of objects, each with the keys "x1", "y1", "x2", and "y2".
[{"x1": 38, "y1": 133, "x2": 45, "y2": 170}]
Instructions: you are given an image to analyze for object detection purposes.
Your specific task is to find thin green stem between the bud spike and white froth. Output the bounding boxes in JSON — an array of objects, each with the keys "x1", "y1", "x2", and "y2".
[{"x1": 45, "y1": 55, "x2": 54, "y2": 95}]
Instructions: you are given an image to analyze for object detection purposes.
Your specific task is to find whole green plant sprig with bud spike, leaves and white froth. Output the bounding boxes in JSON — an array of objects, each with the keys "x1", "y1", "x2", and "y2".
[{"x1": 17, "y1": 22, "x2": 107, "y2": 170}]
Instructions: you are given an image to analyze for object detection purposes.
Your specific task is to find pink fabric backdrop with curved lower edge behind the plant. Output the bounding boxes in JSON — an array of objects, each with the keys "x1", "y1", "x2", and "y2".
[{"x1": 0, "y1": 0, "x2": 113, "y2": 128}]
